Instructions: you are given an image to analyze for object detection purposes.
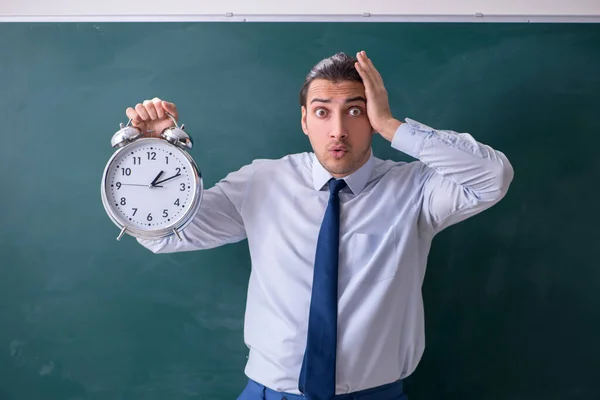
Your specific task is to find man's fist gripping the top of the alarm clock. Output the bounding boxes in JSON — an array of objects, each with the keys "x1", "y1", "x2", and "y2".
[{"x1": 125, "y1": 97, "x2": 179, "y2": 137}]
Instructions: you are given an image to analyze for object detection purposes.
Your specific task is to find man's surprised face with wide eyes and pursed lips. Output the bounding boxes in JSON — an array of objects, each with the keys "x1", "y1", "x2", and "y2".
[{"x1": 302, "y1": 79, "x2": 373, "y2": 178}]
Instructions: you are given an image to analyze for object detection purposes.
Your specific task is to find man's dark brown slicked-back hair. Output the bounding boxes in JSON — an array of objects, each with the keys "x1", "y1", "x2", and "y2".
[{"x1": 300, "y1": 53, "x2": 362, "y2": 106}]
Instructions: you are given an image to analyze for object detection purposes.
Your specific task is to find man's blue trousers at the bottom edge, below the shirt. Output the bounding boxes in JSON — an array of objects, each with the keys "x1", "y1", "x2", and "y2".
[{"x1": 237, "y1": 379, "x2": 408, "y2": 400}]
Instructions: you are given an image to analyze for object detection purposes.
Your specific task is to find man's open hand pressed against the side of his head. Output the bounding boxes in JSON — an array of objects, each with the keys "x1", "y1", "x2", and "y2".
[{"x1": 354, "y1": 51, "x2": 402, "y2": 142}]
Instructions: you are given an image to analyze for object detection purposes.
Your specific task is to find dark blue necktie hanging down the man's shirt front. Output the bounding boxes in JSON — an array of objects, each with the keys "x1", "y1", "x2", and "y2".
[{"x1": 298, "y1": 179, "x2": 346, "y2": 400}]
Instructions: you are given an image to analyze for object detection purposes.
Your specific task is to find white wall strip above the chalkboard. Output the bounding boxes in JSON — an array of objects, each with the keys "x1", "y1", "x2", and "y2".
[{"x1": 0, "y1": 0, "x2": 600, "y2": 22}]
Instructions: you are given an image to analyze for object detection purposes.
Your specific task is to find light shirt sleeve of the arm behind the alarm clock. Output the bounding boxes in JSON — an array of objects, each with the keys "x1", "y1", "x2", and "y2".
[{"x1": 137, "y1": 162, "x2": 257, "y2": 253}]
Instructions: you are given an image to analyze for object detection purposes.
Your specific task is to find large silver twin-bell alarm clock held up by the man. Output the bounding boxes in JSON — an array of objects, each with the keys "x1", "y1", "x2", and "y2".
[{"x1": 101, "y1": 114, "x2": 203, "y2": 240}]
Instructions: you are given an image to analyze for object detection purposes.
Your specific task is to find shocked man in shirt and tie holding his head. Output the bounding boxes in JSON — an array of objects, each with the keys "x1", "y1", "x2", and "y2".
[{"x1": 127, "y1": 52, "x2": 513, "y2": 400}]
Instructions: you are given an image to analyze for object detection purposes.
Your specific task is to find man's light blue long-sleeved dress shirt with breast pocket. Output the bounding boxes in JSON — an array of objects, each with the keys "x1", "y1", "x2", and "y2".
[{"x1": 138, "y1": 119, "x2": 513, "y2": 394}]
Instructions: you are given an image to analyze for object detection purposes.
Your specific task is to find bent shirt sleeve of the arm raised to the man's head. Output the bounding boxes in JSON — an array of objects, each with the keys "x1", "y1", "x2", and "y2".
[{"x1": 392, "y1": 118, "x2": 514, "y2": 234}]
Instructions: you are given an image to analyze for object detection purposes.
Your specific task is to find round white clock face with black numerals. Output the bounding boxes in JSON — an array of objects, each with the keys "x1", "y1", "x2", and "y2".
[{"x1": 104, "y1": 139, "x2": 198, "y2": 232}]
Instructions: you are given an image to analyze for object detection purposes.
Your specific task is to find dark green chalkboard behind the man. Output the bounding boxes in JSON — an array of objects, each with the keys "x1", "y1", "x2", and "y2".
[{"x1": 0, "y1": 23, "x2": 600, "y2": 400}]
